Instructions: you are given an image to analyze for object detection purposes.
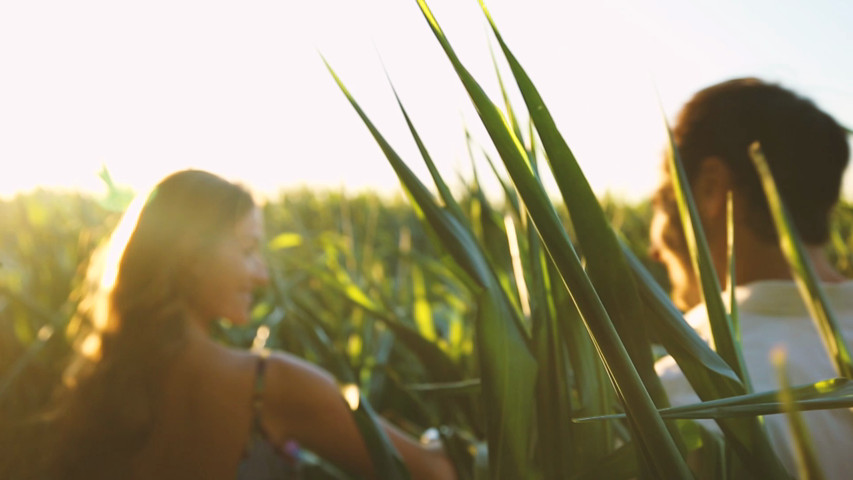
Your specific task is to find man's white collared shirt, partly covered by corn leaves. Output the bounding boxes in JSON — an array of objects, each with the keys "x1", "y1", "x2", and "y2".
[{"x1": 655, "y1": 280, "x2": 853, "y2": 479}]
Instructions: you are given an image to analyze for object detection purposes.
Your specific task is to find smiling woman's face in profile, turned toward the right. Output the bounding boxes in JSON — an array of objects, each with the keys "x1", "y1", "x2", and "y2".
[{"x1": 189, "y1": 208, "x2": 269, "y2": 325}]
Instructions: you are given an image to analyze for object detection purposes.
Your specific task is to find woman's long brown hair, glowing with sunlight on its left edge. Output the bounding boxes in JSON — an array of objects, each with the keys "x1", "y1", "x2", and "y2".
[{"x1": 52, "y1": 170, "x2": 254, "y2": 478}]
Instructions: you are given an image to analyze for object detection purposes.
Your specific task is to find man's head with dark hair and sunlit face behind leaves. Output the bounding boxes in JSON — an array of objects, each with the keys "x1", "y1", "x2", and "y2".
[{"x1": 652, "y1": 78, "x2": 849, "y2": 308}]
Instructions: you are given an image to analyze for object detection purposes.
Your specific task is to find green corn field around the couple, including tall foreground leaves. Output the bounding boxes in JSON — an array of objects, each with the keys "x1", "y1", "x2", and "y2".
[{"x1": 0, "y1": 0, "x2": 853, "y2": 480}]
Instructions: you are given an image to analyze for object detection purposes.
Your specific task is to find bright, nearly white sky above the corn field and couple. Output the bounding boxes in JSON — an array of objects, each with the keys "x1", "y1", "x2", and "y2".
[{"x1": 0, "y1": 0, "x2": 853, "y2": 199}]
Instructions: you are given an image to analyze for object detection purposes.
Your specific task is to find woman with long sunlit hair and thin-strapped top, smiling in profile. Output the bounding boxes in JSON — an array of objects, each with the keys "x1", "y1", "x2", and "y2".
[{"x1": 53, "y1": 170, "x2": 455, "y2": 479}]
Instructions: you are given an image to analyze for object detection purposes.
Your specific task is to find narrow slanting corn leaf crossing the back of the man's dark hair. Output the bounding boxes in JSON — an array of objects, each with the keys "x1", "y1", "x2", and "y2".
[{"x1": 749, "y1": 142, "x2": 853, "y2": 378}]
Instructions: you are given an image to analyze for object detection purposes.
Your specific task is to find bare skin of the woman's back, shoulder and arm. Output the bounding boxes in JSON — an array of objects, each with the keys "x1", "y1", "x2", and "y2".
[{"x1": 135, "y1": 322, "x2": 455, "y2": 479}]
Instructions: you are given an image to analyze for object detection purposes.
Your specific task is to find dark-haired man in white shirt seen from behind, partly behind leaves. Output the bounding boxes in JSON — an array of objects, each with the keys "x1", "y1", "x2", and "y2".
[{"x1": 651, "y1": 78, "x2": 853, "y2": 478}]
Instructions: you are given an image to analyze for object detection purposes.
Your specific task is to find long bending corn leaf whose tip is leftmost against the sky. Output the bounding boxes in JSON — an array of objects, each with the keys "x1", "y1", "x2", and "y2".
[{"x1": 327, "y1": 57, "x2": 539, "y2": 479}]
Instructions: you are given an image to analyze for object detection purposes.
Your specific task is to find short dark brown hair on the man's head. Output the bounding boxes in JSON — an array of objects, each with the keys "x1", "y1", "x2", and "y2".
[{"x1": 673, "y1": 78, "x2": 850, "y2": 245}]
